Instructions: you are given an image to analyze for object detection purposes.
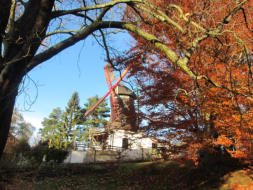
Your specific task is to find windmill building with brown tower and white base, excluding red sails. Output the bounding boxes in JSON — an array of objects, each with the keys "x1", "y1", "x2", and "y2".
[{"x1": 94, "y1": 85, "x2": 157, "y2": 150}]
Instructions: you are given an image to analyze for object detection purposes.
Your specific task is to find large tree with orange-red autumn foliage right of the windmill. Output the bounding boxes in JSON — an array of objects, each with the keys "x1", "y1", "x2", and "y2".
[{"x1": 115, "y1": 0, "x2": 253, "y2": 162}]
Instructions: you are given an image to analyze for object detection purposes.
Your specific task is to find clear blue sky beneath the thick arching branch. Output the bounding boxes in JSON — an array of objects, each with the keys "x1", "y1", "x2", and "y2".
[{"x1": 16, "y1": 33, "x2": 133, "y2": 135}]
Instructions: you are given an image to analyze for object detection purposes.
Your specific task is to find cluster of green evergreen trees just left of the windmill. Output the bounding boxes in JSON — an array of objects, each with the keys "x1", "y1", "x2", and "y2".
[{"x1": 40, "y1": 92, "x2": 110, "y2": 150}]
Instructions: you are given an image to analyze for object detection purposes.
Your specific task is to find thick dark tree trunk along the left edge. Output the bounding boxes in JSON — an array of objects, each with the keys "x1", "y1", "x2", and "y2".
[{"x1": 0, "y1": 0, "x2": 54, "y2": 157}]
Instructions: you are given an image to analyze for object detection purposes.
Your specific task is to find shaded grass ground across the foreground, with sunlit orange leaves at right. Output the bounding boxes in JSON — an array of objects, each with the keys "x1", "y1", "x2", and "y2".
[{"x1": 0, "y1": 161, "x2": 253, "y2": 190}]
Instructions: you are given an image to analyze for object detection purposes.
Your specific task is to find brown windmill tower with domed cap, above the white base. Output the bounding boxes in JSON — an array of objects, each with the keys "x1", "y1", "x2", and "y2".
[{"x1": 106, "y1": 85, "x2": 138, "y2": 131}]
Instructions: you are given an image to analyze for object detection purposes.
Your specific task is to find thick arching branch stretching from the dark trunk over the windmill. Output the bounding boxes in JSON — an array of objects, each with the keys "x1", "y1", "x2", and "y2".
[{"x1": 27, "y1": 21, "x2": 194, "y2": 76}]
